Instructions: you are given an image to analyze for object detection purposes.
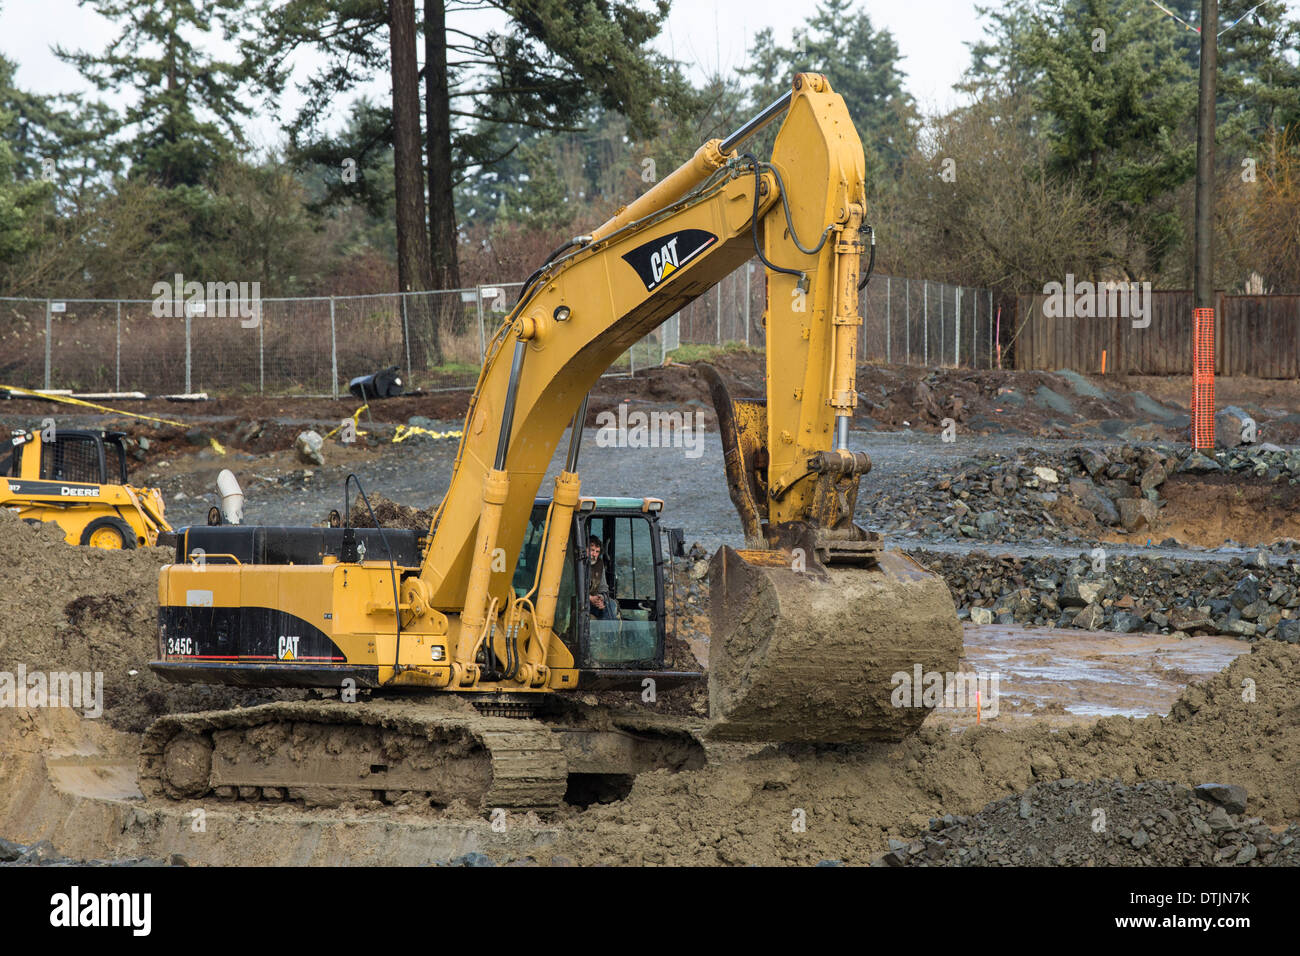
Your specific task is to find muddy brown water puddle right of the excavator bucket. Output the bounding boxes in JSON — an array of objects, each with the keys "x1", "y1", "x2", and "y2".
[{"x1": 944, "y1": 624, "x2": 1251, "y2": 727}]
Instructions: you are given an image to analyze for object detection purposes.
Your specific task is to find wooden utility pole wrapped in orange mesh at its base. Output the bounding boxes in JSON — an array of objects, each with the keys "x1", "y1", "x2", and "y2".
[{"x1": 1192, "y1": 0, "x2": 1218, "y2": 451}]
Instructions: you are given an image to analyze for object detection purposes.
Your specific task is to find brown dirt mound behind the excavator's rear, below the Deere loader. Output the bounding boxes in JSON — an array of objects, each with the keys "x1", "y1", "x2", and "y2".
[{"x1": 0, "y1": 511, "x2": 295, "y2": 731}]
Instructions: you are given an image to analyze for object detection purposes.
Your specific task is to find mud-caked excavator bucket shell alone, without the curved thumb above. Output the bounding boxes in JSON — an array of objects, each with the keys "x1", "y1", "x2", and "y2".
[{"x1": 709, "y1": 548, "x2": 962, "y2": 743}]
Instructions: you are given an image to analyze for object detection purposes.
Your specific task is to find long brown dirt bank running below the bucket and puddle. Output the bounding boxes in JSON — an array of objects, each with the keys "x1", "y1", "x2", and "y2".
[{"x1": 555, "y1": 643, "x2": 1300, "y2": 865}]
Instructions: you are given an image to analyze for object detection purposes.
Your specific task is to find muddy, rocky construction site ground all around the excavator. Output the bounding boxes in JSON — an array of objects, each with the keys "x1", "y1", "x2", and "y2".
[{"x1": 0, "y1": 351, "x2": 1300, "y2": 866}]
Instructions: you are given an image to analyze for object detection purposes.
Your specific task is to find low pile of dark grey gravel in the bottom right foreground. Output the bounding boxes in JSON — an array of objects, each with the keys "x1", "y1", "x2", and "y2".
[{"x1": 875, "y1": 780, "x2": 1300, "y2": 866}]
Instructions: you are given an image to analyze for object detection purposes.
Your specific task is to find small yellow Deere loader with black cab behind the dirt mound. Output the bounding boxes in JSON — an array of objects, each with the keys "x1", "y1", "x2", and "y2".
[{"x1": 0, "y1": 428, "x2": 172, "y2": 550}]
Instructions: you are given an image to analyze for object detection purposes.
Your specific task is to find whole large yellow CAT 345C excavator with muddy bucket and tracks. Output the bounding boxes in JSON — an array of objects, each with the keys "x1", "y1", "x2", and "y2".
[{"x1": 140, "y1": 73, "x2": 961, "y2": 810}]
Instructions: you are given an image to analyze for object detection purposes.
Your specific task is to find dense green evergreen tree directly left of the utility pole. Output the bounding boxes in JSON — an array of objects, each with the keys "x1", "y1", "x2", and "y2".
[{"x1": 967, "y1": 0, "x2": 1196, "y2": 274}]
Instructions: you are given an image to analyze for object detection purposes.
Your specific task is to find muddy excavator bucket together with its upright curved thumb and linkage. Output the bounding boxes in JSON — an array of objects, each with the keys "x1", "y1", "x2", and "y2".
[{"x1": 699, "y1": 365, "x2": 962, "y2": 743}]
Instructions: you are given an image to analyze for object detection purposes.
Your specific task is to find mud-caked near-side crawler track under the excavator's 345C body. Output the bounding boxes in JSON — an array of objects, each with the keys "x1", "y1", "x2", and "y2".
[{"x1": 139, "y1": 701, "x2": 568, "y2": 812}]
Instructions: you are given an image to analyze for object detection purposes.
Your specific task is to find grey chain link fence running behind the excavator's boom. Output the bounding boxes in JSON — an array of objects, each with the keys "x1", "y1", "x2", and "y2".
[{"x1": 0, "y1": 263, "x2": 996, "y2": 397}]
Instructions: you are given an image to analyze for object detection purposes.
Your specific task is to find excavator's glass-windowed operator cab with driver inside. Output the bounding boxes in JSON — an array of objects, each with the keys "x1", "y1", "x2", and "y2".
[{"x1": 514, "y1": 498, "x2": 666, "y2": 684}]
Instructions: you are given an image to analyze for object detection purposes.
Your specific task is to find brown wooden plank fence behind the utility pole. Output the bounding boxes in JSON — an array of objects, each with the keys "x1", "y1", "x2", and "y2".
[{"x1": 1004, "y1": 291, "x2": 1300, "y2": 378}]
